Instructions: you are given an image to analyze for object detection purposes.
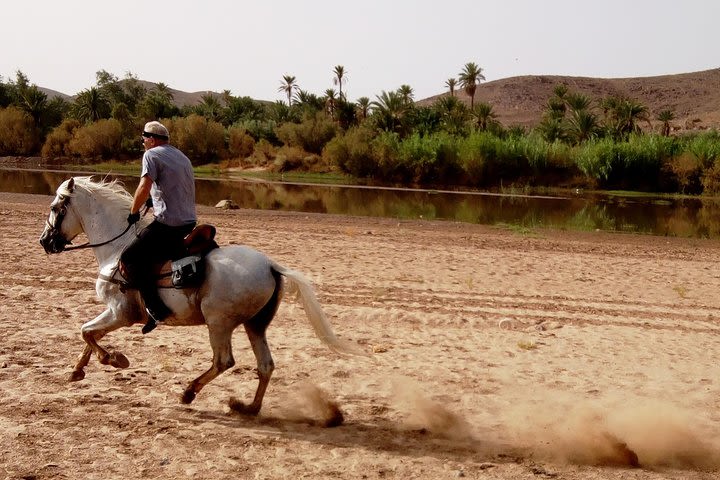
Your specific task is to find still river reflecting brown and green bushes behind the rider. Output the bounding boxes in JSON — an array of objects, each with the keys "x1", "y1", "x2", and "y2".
[{"x1": 5, "y1": 170, "x2": 720, "y2": 238}]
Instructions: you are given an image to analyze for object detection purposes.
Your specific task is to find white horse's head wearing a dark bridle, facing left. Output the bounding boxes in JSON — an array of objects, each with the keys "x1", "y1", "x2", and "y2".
[{"x1": 40, "y1": 178, "x2": 82, "y2": 253}]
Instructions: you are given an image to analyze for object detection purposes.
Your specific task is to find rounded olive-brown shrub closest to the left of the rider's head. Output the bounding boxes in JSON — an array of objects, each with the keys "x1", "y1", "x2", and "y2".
[{"x1": 67, "y1": 118, "x2": 122, "y2": 159}]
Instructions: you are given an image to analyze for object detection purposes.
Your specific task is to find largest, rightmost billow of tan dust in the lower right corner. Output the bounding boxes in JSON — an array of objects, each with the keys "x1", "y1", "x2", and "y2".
[{"x1": 503, "y1": 400, "x2": 720, "y2": 469}]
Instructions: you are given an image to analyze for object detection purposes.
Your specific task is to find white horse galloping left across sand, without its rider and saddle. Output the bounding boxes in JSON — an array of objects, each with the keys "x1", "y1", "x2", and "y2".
[{"x1": 40, "y1": 177, "x2": 363, "y2": 415}]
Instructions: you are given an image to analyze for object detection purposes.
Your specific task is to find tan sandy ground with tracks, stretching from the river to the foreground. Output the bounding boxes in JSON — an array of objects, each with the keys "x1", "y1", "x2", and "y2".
[{"x1": 0, "y1": 189, "x2": 720, "y2": 480}]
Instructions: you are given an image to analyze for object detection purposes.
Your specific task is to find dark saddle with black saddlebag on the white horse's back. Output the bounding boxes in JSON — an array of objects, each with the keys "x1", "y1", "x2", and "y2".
[{"x1": 118, "y1": 224, "x2": 219, "y2": 288}]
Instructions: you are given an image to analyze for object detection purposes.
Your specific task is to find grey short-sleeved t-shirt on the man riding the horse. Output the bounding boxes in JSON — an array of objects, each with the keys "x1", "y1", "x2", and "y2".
[{"x1": 140, "y1": 144, "x2": 197, "y2": 227}]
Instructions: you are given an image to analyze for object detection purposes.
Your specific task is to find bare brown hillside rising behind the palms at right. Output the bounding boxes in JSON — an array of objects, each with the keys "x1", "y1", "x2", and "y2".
[{"x1": 417, "y1": 69, "x2": 720, "y2": 130}]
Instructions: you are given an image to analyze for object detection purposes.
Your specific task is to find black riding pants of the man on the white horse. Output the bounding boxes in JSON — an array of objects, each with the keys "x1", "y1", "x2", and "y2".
[{"x1": 120, "y1": 220, "x2": 195, "y2": 316}]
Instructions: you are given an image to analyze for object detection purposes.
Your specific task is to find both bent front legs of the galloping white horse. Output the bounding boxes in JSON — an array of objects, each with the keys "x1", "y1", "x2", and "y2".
[{"x1": 70, "y1": 308, "x2": 132, "y2": 381}]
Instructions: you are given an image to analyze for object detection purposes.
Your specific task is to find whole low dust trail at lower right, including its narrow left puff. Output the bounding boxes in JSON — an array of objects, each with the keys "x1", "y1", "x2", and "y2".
[{"x1": 391, "y1": 377, "x2": 720, "y2": 470}]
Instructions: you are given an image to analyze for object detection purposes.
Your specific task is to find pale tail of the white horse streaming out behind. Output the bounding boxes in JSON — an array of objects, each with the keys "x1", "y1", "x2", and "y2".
[{"x1": 272, "y1": 262, "x2": 368, "y2": 356}]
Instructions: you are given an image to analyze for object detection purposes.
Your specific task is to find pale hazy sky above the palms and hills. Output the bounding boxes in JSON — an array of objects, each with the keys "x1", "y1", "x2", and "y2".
[{"x1": 0, "y1": 0, "x2": 720, "y2": 100}]
